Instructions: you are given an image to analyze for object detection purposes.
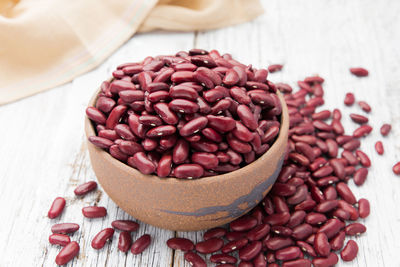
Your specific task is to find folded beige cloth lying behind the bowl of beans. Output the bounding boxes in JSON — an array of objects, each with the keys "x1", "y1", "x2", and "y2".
[{"x1": 0, "y1": 0, "x2": 263, "y2": 104}]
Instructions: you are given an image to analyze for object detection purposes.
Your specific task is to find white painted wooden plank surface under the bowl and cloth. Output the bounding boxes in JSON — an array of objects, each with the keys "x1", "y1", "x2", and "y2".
[{"x1": 0, "y1": 0, "x2": 400, "y2": 267}]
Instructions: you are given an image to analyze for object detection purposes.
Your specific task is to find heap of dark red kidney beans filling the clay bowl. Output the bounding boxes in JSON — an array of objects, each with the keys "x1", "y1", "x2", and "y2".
[{"x1": 86, "y1": 49, "x2": 282, "y2": 179}]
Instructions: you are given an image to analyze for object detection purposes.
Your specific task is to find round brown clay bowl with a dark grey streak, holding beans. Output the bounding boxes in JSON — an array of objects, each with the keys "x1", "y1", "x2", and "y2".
[{"x1": 85, "y1": 86, "x2": 289, "y2": 231}]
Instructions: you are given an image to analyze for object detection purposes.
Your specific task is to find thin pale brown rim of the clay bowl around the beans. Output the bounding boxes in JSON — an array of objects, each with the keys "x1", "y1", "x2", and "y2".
[{"x1": 85, "y1": 78, "x2": 289, "y2": 185}]
